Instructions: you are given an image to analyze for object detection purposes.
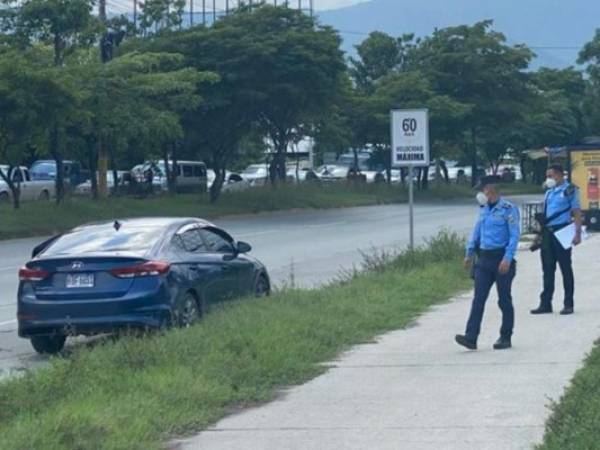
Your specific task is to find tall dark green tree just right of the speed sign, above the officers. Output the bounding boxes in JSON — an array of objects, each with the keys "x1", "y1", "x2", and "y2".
[{"x1": 416, "y1": 21, "x2": 534, "y2": 183}]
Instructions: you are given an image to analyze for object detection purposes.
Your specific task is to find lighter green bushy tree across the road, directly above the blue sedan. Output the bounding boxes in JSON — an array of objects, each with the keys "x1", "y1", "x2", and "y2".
[{"x1": 79, "y1": 52, "x2": 216, "y2": 197}]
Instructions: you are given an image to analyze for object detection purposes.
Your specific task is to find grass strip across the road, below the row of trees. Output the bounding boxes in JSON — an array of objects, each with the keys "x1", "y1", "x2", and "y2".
[{"x1": 0, "y1": 184, "x2": 536, "y2": 240}]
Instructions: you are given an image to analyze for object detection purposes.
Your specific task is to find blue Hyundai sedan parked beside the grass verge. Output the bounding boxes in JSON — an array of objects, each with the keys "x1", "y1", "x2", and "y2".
[{"x1": 17, "y1": 218, "x2": 271, "y2": 353}]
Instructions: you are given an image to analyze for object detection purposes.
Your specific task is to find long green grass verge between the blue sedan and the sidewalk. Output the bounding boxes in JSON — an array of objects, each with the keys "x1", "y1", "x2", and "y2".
[{"x1": 0, "y1": 233, "x2": 469, "y2": 450}]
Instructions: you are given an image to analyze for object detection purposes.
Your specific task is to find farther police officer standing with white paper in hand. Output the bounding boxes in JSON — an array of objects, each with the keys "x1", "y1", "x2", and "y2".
[{"x1": 531, "y1": 164, "x2": 582, "y2": 315}]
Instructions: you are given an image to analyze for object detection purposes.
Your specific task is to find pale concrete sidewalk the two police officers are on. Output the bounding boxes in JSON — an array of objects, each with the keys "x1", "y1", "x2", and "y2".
[{"x1": 178, "y1": 237, "x2": 600, "y2": 450}]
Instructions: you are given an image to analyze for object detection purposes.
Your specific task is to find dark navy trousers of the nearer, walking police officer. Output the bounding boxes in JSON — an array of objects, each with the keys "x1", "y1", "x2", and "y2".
[{"x1": 466, "y1": 251, "x2": 516, "y2": 341}]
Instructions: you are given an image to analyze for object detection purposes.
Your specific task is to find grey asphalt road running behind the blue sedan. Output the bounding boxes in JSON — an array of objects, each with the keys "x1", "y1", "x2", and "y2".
[{"x1": 0, "y1": 197, "x2": 531, "y2": 377}]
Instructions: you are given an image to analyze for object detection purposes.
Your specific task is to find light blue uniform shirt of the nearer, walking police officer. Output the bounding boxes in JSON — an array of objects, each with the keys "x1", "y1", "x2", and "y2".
[{"x1": 467, "y1": 198, "x2": 521, "y2": 261}]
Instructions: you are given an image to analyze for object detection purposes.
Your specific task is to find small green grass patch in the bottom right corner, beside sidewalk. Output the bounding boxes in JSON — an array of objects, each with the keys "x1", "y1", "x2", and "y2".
[{"x1": 537, "y1": 341, "x2": 600, "y2": 450}]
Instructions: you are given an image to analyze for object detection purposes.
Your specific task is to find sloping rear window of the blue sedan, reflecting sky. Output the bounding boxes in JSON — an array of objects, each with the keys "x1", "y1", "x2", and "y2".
[{"x1": 43, "y1": 224, "x2": 164, "y2": 256}]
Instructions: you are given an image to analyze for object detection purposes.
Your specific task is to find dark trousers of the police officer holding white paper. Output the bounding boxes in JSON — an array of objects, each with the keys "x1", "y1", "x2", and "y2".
[{"x1": 540, "y1": 226, "x2": 575, "y2": 309}]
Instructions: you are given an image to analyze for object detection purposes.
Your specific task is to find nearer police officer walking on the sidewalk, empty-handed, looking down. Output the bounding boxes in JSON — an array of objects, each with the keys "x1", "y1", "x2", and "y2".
[{"x1": 456, "y1": 177, "x2": 521, "y2": 350}]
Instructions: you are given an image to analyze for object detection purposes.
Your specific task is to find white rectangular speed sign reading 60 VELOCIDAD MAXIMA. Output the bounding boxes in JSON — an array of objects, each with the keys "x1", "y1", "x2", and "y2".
[{"x1": 392, "y1": 109, "x2": 430, "y2": 167}]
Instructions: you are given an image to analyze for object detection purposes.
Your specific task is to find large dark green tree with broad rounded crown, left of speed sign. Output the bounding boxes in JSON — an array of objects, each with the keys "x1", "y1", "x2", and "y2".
[{"x1": 193, "y1": 5, "x2": 346, "y2": 181}]
